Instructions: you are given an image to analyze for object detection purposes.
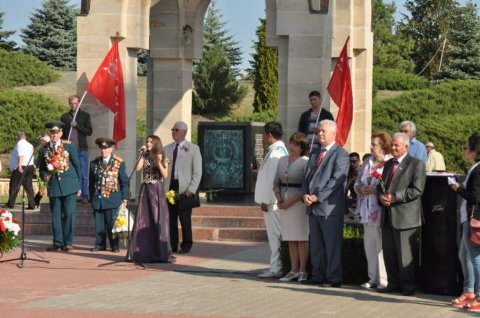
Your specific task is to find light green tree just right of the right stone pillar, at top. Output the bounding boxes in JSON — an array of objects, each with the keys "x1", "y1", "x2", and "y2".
[{"x1": 372, "y1": 0, "x2": 414, "y2": 71}]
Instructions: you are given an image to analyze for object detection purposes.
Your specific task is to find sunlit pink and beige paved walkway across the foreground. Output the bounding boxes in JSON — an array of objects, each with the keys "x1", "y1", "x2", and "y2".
[{"x1": 0, "y1": 236, "x2": 474, "y2": 318}]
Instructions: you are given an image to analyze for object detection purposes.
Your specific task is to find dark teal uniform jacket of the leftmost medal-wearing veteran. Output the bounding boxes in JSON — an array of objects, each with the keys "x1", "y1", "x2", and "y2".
[{"x1": 39, "y1": 141, "x2": 81, "y2": 197}]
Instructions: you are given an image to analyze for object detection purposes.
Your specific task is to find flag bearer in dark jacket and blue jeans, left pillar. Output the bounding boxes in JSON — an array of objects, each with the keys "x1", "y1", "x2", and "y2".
[{"x1": 60, "y1": 95, "x2": 93, "y2": 203}]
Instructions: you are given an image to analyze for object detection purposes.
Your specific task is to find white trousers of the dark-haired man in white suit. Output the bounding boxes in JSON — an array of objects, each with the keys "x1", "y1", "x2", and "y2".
[{"x1": 263, "y1": 204, "x2": 282, "y2": 273}]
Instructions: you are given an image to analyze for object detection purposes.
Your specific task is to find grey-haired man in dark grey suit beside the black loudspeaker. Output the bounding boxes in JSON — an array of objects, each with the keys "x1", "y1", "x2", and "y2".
[{"x1": 377, "y1": 133, "x2": 426, "y2": 295}]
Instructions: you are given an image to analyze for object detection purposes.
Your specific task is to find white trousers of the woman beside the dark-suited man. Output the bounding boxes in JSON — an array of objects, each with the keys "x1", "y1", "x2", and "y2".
[{"x1": 363, "y1": 224, "x2": 388, "y2": 286}]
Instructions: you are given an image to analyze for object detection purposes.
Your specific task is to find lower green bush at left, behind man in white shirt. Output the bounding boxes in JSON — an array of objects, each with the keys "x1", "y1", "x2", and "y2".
[{"x1": 0, "y1": 90, "x2": 65, "y2": 153}]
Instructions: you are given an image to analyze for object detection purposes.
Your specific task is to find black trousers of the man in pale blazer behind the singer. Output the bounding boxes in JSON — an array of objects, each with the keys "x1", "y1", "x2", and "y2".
[{"x1": 168, "y1": 180, "x2": 193, "y2": 252}]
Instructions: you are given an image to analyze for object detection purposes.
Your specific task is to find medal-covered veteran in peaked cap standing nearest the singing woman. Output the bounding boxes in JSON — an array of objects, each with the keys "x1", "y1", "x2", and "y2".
[{"x1": 88, "y1": 137, "x2": 128, "y2": 253}]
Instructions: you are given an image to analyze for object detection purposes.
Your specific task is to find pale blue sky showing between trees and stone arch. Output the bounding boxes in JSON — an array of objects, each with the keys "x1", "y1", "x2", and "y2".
[{"x1": 0, "y1": 0, "x2": 480, "y2": 69}]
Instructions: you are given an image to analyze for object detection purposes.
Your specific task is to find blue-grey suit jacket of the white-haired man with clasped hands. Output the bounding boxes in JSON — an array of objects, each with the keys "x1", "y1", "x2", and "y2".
[{"x1": 302, "y1": 144, "x2": 350, "y2": 216}]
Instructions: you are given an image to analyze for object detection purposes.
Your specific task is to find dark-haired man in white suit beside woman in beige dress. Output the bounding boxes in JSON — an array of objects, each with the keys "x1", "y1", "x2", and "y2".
[{"x1": 255, "y1": 122, "x2": 288, "y2": 278}]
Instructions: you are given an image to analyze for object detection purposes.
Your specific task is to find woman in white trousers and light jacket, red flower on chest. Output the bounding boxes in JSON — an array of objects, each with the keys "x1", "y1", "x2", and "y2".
[{"x1": 354, "y1": 131, "x2": 392, "y2": 289}]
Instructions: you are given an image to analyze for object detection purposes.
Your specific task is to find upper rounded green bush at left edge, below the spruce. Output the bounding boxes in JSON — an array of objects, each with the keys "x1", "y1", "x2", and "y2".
[{"x1": 0, "y1": 50, "x2": 60, "y2": 89}]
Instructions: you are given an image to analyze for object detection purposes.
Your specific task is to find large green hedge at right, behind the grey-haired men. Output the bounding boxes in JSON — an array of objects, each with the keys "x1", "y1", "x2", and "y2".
[{"x1": 372, "y1": 80, "x2": 480, "y2": 172}]
